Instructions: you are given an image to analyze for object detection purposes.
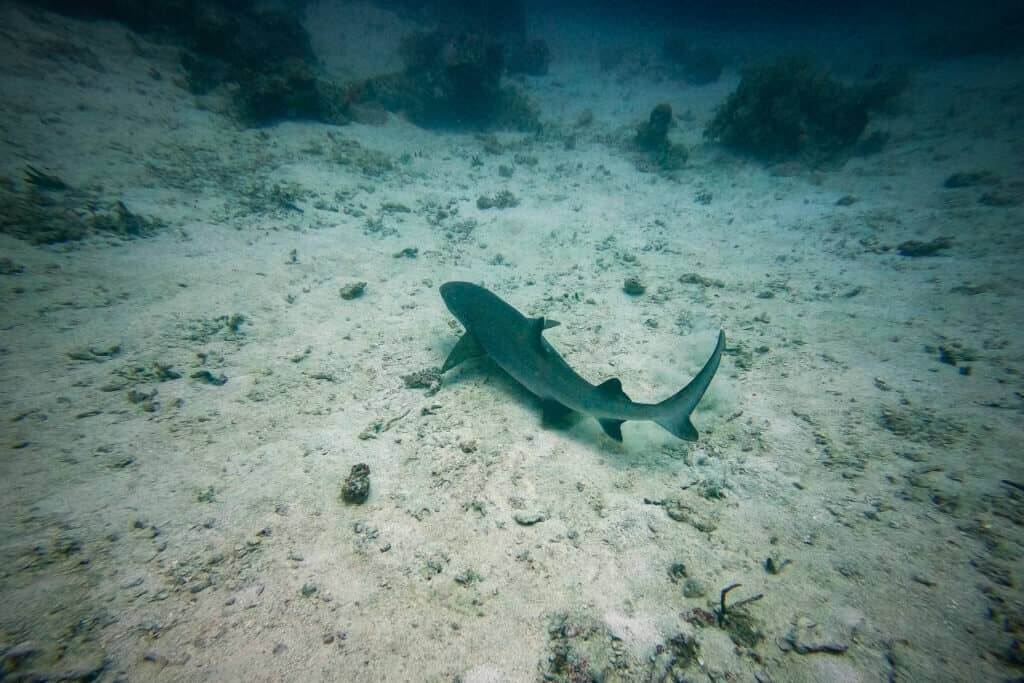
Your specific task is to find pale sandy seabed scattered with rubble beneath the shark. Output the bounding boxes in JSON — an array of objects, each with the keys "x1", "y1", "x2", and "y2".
[{"x1": 0, "y1": 6, "x2": 1024, "y2": 682}]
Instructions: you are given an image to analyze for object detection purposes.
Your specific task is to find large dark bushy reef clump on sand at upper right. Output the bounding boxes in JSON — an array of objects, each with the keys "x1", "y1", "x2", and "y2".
[{"x1": 705, "y1": 57, "x2": 907, "y2": 162}]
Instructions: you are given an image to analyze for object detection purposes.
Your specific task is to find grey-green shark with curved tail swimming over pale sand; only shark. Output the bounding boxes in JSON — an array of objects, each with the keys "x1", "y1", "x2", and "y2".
[{"x1": 440, "y1": 282, "x2": 725, "y2": 441}]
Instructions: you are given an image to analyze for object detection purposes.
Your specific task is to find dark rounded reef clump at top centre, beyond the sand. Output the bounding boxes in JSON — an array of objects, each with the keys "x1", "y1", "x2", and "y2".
[{"x1": 359, "y1": 31, "x2": 539, "y2": 130}]
